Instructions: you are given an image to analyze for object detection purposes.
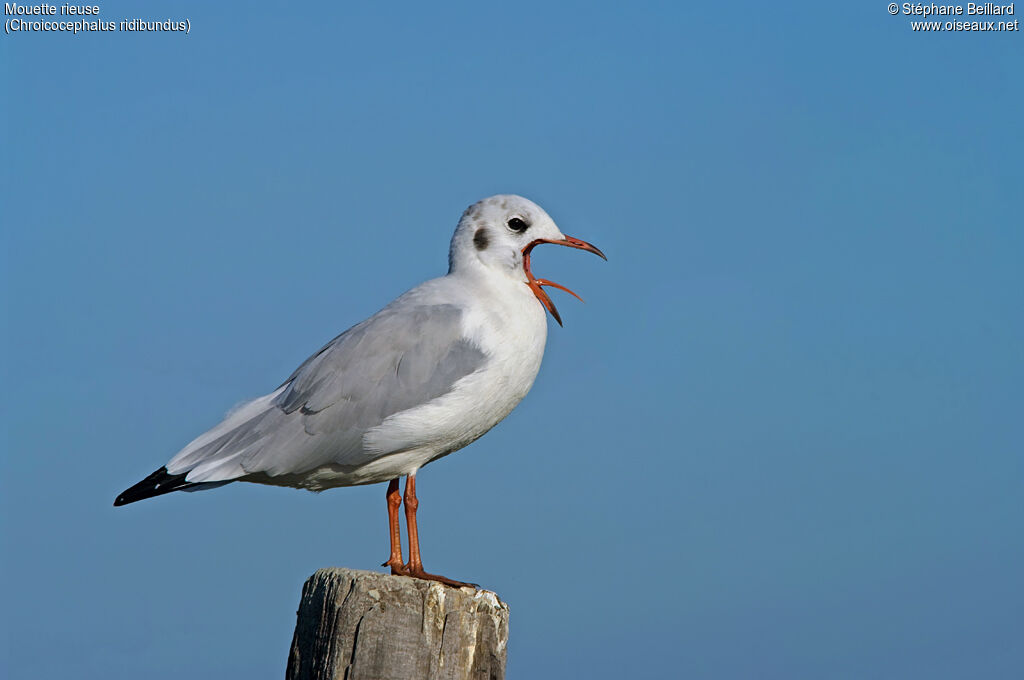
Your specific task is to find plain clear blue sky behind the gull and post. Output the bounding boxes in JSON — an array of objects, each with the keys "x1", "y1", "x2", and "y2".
[{"x1": 0, "y1": 1, "x2": 1024, "y2": 679}]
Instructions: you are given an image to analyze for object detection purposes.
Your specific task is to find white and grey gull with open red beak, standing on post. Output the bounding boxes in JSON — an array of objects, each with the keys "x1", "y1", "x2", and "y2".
[{"x1": 114, "y1": 195, "x2": 607, "y2": 587}]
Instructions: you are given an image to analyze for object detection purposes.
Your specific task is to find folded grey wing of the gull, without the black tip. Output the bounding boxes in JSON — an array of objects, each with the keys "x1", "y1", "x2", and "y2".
[{"x1": 167, "y1": 304, "x2": 486, "y2": 481}]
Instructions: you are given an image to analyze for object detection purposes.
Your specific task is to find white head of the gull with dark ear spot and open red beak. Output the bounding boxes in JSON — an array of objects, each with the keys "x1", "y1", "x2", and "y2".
[{"x1": 449, "y1": 194, "x2": 608, "y2": 326}]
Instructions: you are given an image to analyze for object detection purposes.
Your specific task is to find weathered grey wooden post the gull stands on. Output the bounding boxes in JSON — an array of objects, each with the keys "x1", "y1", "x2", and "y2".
[{"x1": 286, "y1": 568, "x2": 509, "y2": 680}]
